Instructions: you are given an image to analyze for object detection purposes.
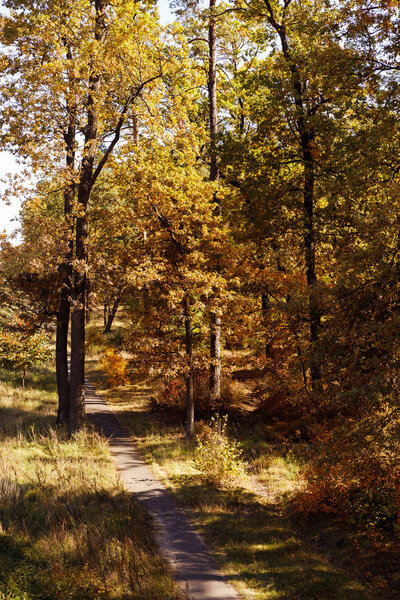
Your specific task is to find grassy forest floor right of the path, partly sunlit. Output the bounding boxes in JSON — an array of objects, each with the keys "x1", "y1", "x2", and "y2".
[{"x1": 87, "y1": 356, "x2": 400, "y2": 600}]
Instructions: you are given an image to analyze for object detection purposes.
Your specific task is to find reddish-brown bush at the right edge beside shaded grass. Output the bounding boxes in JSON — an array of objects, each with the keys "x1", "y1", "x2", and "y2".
[{"x1": 299, "y1": 430, "x2": 400, "y2": 529}]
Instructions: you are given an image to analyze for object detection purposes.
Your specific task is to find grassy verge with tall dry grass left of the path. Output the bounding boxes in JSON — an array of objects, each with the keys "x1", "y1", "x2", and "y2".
[{"x1": 0, "y1": 368, "x2": 178, "y2": 600}]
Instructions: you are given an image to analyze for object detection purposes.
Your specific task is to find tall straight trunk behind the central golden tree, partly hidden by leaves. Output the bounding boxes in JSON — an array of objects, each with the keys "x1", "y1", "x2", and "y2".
[{"x1": 208, "y1": 0, "x2": 221, "y2": 404}]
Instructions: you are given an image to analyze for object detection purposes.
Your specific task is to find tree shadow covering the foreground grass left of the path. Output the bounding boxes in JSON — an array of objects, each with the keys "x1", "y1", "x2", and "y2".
[{"x1": 0, "y1": 482, "x2": 178, "y2": 600}]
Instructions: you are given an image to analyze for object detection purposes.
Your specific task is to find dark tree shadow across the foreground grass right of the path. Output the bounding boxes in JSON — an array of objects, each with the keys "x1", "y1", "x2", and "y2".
[{"x1": 167, "y1": 475, "x2": 376, "y2": 600}]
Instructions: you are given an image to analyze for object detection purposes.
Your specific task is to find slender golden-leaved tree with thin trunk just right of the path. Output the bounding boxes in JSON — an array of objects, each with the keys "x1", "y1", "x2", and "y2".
[{"x1": 105, "y1": 112, "x2": 231, "y2": 438}]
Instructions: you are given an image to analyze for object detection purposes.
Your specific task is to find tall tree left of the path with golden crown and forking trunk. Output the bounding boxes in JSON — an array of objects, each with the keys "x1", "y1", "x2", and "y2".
[{"x1": 2, "y1": 0, "x2": 171, "y2": 432}]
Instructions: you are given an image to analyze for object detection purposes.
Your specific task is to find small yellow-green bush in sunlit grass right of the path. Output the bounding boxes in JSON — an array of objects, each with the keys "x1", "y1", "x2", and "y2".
[{"x1": 194, "y1": 415, "x2": 246, "y2": 487}]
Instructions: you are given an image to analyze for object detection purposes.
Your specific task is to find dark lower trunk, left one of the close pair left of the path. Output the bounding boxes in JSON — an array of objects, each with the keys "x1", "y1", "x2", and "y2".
[{"x1": 56, "y1": 286, "x2": 70, "y2": 425}]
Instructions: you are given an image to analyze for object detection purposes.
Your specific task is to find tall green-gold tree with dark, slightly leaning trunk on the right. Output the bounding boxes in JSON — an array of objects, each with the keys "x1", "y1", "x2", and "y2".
[{"x1": 216, "y1": 1, "x2": 394, "y2": 396}]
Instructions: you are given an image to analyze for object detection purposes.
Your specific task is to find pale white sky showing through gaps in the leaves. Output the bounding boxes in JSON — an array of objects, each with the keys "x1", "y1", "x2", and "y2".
[{"x1": 0, "y1": 0, "x2": 174, "y2": 241}]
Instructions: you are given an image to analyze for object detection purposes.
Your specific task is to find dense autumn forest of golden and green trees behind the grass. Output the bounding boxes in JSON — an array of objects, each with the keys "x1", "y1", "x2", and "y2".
[{"x1": 0, "y1": 0, "x2": 400, "y2": 599}]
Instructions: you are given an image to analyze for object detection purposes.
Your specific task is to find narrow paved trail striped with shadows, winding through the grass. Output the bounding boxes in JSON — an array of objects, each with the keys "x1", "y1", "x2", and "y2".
[{"x1": 85, "y1": 380, "x2": 239, "y2": 600}]
